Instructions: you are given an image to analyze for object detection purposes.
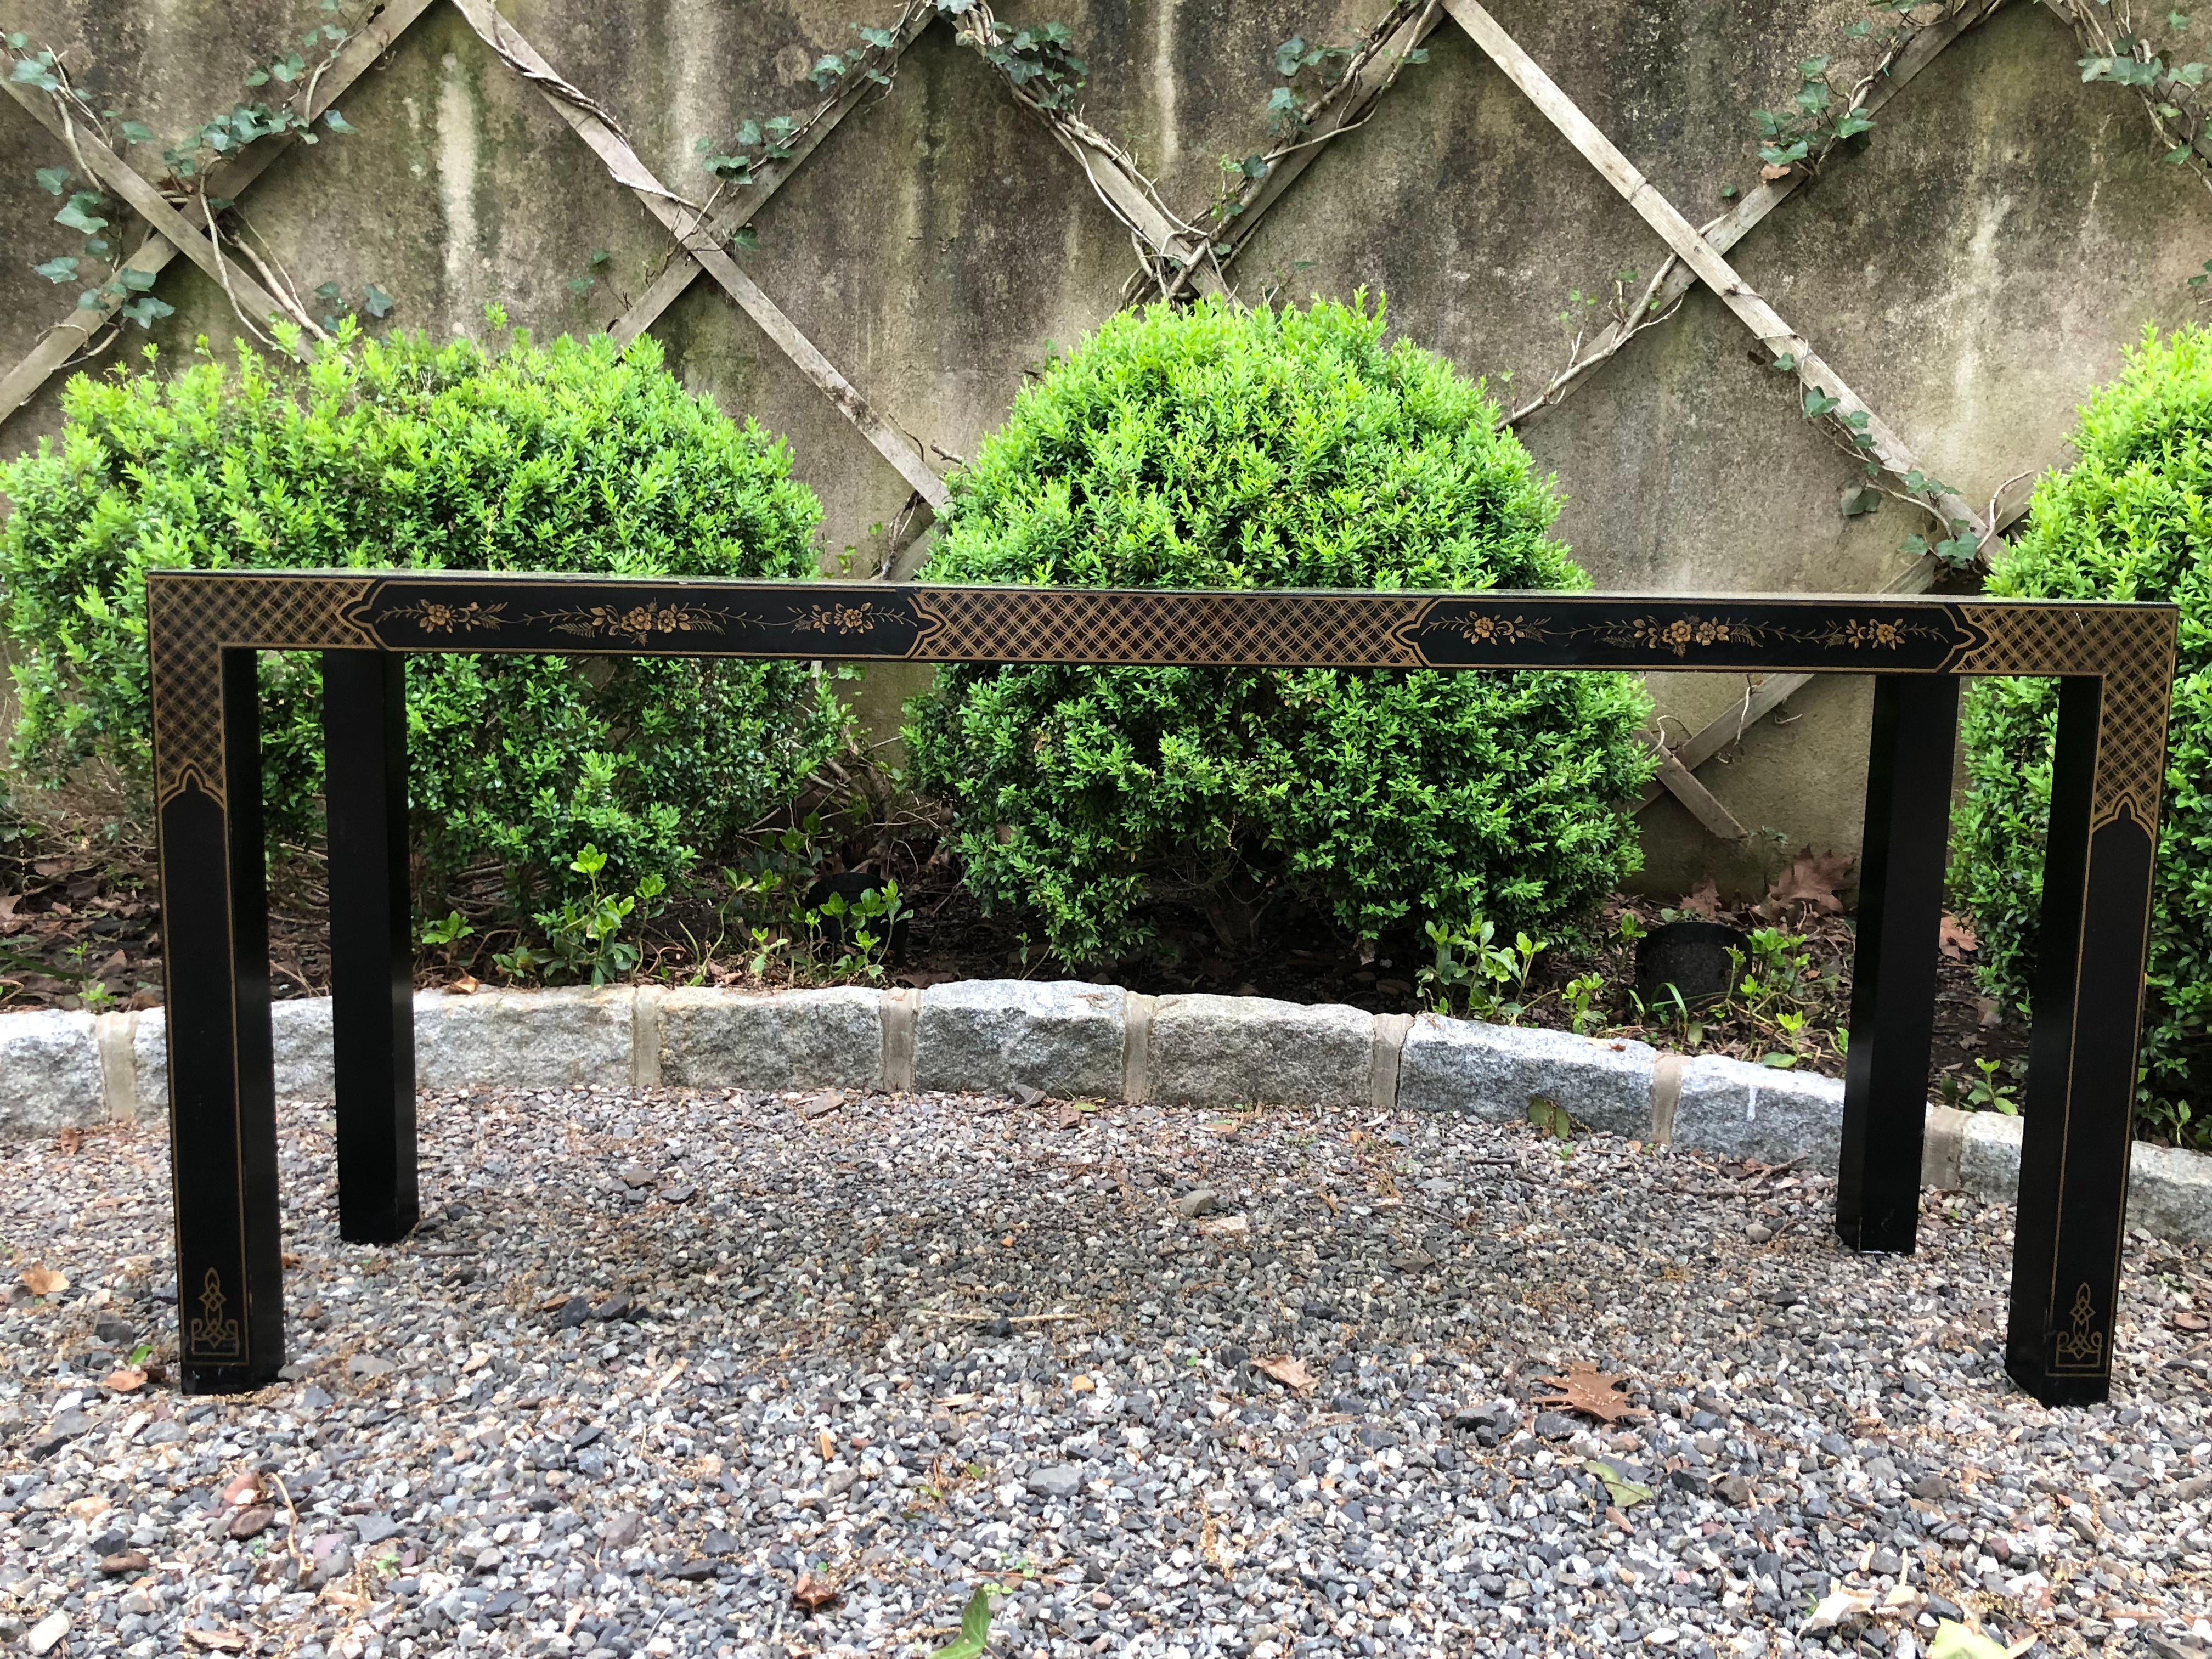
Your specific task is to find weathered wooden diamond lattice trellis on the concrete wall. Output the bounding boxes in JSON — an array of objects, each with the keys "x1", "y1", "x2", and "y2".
[{"x1": 0, "y1": 0, "x2": 2208, "y2": 840}]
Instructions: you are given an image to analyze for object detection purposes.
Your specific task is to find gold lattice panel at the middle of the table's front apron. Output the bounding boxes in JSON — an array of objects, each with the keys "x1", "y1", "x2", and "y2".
[{"x1": 913, "y1": 589, "x2": 1427, "y2": 668}]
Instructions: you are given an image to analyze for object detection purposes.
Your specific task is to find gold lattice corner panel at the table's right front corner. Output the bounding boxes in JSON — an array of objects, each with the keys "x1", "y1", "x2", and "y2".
[{"x1": 1957, "y1": 604, "x2": 2176, "y2": 832}]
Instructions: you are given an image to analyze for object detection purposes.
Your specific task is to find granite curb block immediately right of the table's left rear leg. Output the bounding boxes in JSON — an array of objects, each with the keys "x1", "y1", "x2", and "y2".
[{"x1": 416, "y1": 986, "x2": 633, "y2": 1088}]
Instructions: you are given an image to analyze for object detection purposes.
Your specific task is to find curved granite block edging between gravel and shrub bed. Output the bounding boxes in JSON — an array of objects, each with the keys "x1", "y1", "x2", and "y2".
[{"x1": 0, "y1": 980, "x2": 2212, "y2": 1241}]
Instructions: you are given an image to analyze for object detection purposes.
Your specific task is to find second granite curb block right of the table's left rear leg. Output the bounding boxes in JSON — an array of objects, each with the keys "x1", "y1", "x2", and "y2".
[{"x1": 662, "y1": 984, "x2": 883, "y2": 1088}]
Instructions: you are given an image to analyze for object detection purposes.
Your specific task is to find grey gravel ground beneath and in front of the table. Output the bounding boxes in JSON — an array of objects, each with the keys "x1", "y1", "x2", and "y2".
[{"x1": 0, "y1": 1091, "x2": 2212, "y2": 1659}]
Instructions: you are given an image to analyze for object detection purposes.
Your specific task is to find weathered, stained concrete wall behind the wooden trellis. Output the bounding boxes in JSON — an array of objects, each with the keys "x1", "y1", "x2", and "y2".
[{"x1": 0, "y1": 0, "x2": 2212, "y2": 891}]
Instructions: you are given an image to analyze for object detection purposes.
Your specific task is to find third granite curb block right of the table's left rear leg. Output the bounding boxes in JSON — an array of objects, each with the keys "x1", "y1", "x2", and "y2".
[{"x1": 913, "y1": 980, "x2": 1126, "y2": 1099}]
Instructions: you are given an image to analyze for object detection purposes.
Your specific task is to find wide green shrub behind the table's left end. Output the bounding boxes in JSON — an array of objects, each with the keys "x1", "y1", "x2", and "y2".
[{"x1": 0, "y1": 319, "x2": 843, "y2": 902}]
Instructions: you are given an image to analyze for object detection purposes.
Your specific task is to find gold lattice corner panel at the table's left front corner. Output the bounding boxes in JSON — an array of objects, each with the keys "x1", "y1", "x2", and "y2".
[{"x1": 146, "y1": 571, "x2": 376, "y2": 808}]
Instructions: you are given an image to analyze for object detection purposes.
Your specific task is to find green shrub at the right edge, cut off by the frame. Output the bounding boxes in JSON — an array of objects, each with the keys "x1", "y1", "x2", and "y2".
[{"x1": 1951, "y1": 328, "x2": 2212, "y2": 1146}]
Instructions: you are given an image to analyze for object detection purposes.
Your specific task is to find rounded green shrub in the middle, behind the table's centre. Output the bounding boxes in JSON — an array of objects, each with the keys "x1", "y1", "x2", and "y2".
[{"x1": 907, "y1": 296, "x2": 1650, "y2": 962}]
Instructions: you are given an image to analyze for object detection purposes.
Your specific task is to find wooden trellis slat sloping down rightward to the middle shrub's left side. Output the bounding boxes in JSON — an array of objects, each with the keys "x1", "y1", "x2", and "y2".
[{"x1": 454, "y1": 0, "x2": 949, "y2": 506}]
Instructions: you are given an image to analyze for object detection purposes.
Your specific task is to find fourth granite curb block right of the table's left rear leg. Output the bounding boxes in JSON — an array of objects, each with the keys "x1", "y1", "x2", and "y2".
[{"x1": 1148, "y1": 995, "x2": 1376, "y2": 1106}]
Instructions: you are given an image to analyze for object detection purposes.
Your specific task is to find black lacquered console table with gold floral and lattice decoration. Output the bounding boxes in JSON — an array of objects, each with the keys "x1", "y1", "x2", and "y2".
[{"x1": 148, "y1": 571, "x2": 2176, "y2": 1402}]
